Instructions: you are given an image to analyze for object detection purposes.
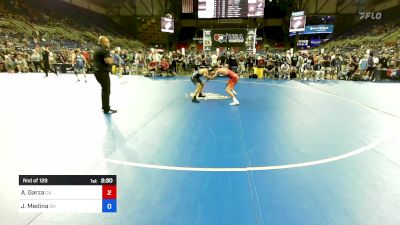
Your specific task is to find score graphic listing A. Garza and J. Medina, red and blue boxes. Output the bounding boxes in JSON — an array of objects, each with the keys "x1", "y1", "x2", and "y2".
[{"x1": 18, "y1": 175, "x2": 117, "y2": 213}]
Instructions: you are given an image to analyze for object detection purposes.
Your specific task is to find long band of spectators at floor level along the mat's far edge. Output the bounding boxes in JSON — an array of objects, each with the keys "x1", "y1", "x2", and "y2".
[{"x1": 0, "y1": 42, "x2": 400, "y2": 81}]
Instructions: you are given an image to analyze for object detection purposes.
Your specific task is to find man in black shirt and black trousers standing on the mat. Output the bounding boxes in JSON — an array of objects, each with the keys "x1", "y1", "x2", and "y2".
[{"x1": 93, "y1": 36, "x2": 117, "y2": 114}]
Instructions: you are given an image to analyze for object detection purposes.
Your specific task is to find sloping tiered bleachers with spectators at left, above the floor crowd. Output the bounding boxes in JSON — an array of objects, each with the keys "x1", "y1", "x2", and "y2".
[{"x1": 0, "y1": 0, "x2": 143, "y2": 51}]
